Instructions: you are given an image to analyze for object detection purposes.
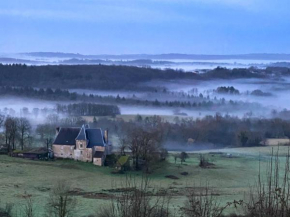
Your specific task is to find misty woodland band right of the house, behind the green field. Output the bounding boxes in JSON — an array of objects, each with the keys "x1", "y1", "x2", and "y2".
[{"x1": 95, "y1": 114, "x2": 290, "y2": 150}]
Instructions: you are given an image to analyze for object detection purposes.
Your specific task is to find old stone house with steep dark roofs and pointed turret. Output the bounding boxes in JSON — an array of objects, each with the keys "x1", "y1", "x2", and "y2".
[{"x1": 52, "y1": 125, "x2": 112, "y2": 166}]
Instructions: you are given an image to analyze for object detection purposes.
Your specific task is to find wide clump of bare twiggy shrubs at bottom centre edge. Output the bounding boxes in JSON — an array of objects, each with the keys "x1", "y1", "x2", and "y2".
[{"x1": 96, "y1": 176, "x2": 172, "y2": 217}]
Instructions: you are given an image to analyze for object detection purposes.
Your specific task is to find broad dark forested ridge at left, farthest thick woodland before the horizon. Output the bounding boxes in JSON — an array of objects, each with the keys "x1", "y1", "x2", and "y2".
[{"x1": 0, "y1": 64, "x2": 198, "y2": 90}]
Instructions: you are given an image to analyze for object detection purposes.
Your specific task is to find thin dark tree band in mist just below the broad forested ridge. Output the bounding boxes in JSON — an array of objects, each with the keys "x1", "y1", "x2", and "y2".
[{"x1": 0, "y1": 86, "x2": 257, "y2": 110}]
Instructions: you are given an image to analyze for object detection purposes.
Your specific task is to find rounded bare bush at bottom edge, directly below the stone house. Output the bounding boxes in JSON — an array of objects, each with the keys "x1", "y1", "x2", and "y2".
[{"x1": 47, "y1": 181, "x2": 77, "y2": 217}]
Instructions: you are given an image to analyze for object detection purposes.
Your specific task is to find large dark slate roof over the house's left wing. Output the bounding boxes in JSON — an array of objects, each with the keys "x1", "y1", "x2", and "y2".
[{"x1": 53, "y1": 127, "x2": 80, "y2": 145}]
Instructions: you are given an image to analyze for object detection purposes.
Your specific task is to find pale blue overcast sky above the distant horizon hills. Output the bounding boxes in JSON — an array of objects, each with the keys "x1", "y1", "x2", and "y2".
[{"x1": 0, "y1": 0, "x2": 290, "y2": 54}]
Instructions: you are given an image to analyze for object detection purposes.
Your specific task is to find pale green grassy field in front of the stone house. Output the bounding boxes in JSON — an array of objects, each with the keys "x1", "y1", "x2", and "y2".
[{"x1": 0, "y1": 147, "x2": 288, "y2": 216}]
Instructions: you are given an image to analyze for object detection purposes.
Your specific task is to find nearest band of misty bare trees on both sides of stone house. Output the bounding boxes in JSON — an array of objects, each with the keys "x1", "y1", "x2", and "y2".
[{"x1": 0, "y1": 114, "x2": 290, "y2": 156}]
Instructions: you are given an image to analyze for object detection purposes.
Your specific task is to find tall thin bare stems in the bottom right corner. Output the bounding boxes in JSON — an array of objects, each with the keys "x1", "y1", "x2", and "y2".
[{"x1": 243, "y1": 149, "x2": 290, "y2": 217}]
